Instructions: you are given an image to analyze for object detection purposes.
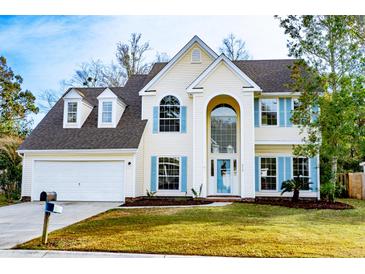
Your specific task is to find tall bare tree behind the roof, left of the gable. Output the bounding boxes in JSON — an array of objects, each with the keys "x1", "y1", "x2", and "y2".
[{"x1": 116, "y1": 33, "x2": 151, "y2": 77}]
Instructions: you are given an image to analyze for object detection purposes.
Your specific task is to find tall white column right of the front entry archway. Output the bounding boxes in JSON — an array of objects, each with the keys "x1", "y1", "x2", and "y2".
[{"x1": 240, "y1": 92, "x2": 255, "y2": 198}]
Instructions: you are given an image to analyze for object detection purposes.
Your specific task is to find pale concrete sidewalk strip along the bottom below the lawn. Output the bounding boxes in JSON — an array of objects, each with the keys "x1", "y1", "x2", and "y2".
[{"x1": 0, "y1": 250, "x2": 200, "y2": 258}]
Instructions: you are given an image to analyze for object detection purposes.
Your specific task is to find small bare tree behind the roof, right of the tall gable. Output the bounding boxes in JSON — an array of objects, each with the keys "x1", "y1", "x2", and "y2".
[{"x1": 219, "y1": 33, "x2": 250, "y2": 61}]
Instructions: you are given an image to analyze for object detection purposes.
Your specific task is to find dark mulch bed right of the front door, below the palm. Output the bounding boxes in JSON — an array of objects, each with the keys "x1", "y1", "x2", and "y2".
[{"x1": 238, "y1": 199, "x2": 354, "y2": 210}]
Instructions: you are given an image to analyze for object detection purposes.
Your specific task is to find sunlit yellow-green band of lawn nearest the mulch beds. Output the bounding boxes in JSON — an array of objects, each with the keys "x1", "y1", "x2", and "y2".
[{"x1": 64, "y1": 201, "x2": 365, "y2": 233}]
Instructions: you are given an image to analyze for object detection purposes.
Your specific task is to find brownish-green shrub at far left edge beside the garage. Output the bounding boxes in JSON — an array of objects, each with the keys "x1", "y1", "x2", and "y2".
[{"x1": 0, "y1": 141, "x2": 22, "y2": 200}]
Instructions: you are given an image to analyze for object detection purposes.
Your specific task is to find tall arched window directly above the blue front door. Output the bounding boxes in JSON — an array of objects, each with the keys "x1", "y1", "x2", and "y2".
[{"x1": 210, "y1": 104, "x2": 237, "y2": 153}]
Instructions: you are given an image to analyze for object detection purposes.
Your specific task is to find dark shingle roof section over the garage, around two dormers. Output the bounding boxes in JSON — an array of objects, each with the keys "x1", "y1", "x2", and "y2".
[{"x1": 19, "y1": 75, "x2": 147, "y2": 150}]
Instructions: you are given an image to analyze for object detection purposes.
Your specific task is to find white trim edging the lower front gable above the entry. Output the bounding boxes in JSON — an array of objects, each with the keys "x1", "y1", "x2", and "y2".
[{"x1": 186, "y1": 54, "x2": 261, "y2": 94}]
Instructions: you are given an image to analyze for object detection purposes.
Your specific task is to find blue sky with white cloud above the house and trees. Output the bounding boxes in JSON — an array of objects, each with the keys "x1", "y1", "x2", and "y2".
[{"x1": 0, "y1": 16, "x2": 288, "y2": 124}]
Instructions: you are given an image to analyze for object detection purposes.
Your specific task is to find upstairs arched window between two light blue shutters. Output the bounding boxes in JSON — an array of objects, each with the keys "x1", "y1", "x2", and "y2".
[{"x1": 160, "y1": 95, "x2": 180, "y2": 132}]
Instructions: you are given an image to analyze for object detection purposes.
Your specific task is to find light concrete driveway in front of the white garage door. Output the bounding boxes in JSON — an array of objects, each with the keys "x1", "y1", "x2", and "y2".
[{"x1": 0, "y1": 202, "x2": 120, "y2": 249}]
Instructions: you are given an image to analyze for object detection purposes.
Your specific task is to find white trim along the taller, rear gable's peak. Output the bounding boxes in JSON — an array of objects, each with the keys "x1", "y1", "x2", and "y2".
[{"x1": 139, "y1": 35, "x2": 218, "y2": 96}]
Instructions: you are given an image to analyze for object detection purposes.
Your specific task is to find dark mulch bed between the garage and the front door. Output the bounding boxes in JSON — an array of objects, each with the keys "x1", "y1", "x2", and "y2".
[{"x1": 121, "y1": 198, "x2": 213, "y2": 207}]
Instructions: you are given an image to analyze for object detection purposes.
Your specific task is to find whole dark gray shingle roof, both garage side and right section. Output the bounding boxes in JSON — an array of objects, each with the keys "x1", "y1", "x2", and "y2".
[{"x1": 19, "y1": 59, "x2": 295, "y2": 150}]
